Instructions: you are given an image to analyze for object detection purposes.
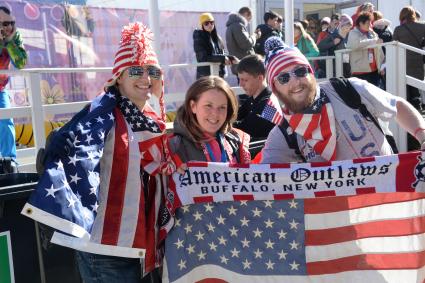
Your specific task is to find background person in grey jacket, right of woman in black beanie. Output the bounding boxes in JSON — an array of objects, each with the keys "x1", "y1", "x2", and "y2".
[{"x1": 226, "y1": 7, "x2": 261, "y2": 75}]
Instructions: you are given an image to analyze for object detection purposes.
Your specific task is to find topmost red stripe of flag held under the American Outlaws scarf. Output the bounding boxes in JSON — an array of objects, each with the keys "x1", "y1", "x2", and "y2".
[{"x1": 304, "y1": 193, "x2": 425, "y2": 214}]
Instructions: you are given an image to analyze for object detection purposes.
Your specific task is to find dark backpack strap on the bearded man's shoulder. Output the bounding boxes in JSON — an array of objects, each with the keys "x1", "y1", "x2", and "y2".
[{"x1": 329, "y1": 78, "x2": 398, "y2": 153}]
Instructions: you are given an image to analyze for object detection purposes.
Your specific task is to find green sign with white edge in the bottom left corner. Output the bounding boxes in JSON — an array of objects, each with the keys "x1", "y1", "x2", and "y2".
[{"x1": 0, "y1": 231, "x2": 15, "y2": 283}]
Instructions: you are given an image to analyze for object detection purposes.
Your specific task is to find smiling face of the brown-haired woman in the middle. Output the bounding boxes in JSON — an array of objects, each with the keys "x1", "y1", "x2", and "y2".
[{"x1": 190, "y1": 89, "x2": 228, "y2": 136}]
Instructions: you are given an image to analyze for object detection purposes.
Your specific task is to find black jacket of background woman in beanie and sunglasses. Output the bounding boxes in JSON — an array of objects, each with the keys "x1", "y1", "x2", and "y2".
[{"x1": 193, "y1": 29, "x2": 226, "y2": 79}]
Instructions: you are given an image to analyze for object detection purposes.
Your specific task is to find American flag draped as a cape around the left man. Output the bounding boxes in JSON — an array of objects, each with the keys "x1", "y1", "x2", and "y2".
[{"x1": 22, "y1": 93, "x2": 171, "y2": 272}]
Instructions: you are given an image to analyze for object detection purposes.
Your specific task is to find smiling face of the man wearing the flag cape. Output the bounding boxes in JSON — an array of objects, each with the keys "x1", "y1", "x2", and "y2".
[{"x1": 117, "y1": 65, "x2": 161, "y2": 110}]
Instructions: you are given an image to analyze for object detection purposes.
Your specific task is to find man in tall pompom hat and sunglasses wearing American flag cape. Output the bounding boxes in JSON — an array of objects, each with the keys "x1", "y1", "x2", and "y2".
[{"x1": 22, "y1": 23, "x2": 175, "y2": 283}]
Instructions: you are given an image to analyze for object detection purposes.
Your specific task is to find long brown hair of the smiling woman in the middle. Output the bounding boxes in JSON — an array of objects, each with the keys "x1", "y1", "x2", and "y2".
[{"x1": 176, "y1": 76, "x2": 238, "y2": 144}]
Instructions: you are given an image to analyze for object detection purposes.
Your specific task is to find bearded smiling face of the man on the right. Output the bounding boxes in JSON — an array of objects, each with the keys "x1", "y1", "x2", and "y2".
[{"x1": 273, "y1": 65, "x2": 316, "y2": 113}]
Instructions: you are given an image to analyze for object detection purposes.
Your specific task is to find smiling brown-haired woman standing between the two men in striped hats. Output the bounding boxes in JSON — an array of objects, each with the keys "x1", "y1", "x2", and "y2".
[{"x1": 170, "y1": 76, "x2": 250, "y2": 163}]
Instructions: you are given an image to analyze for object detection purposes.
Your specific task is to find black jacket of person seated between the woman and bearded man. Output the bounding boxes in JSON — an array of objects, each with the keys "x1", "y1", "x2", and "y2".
[{"x1": 233, "y1": 87, "x2": 275, "y2": 141}]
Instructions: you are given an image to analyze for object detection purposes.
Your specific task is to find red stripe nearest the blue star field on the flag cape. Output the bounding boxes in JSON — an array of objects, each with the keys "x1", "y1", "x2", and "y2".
[{"x1": 101, "y1": 108, "x2": 129, "y2": 245}]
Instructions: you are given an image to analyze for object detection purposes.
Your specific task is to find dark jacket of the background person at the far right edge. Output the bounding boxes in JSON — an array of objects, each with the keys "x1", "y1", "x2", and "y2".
[{"x1": 393, "y1": 22, "x2": 425, "y2": 80}]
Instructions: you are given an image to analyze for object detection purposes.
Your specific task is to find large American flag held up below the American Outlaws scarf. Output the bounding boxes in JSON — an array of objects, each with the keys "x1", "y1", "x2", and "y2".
[{"x1": 163, "y1": 193, "x2": 425, "y2": 283}]
